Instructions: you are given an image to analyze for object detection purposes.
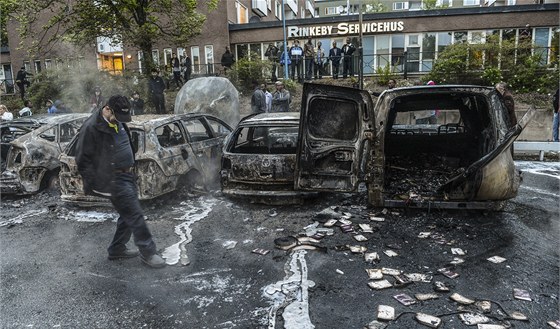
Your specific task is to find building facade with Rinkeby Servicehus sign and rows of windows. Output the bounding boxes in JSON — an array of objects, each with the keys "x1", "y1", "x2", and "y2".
[{"x1": 0, "y1": 0, "x2": 560, "y2": 93}]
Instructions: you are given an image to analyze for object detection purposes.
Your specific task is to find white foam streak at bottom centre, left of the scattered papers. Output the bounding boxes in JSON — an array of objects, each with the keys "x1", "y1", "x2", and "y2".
[{"x1": 263, "y1": 250, "x2": 315, "y2": 329}]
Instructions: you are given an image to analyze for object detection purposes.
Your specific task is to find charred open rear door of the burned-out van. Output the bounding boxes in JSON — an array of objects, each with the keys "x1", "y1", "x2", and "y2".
[{"x1": 295, "y1": 84, "x2": 375, "y2": 192}]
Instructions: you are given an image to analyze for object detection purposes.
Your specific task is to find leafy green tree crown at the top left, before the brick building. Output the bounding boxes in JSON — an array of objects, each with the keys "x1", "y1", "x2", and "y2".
[{"x1": 12, "y1": 0, "x2": 219, "y2": 74}]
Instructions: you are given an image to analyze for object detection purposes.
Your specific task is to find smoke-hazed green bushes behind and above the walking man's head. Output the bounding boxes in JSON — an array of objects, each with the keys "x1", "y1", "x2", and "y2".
[{"x1": 27, "y1": 68, "x2": 147, "y2": 113}]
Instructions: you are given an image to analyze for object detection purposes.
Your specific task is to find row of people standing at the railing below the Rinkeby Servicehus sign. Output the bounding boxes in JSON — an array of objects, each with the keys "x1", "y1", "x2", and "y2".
[{"x1": 272, "y1": 38, "x2": 356, "y2": 82}]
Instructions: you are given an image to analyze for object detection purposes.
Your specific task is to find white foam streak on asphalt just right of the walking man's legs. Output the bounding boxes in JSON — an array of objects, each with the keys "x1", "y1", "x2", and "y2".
[{"x1": 162, "y1": 199, "x2": 216, "y2": 265}]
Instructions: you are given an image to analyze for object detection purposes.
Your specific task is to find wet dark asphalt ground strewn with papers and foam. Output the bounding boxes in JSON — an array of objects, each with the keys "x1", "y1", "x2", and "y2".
[{"x1": 0, "y1": 161, "x2": 560, "y2": 329}]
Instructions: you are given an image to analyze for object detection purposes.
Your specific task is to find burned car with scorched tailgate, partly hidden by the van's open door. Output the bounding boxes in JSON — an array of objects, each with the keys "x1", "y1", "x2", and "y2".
[{"x1": 221, "y1": 112, "x2": 318, "y2": 204}]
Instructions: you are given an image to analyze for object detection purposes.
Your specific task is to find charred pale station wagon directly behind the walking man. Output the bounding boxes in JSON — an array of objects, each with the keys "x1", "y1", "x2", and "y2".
[{"x1": 60, "y1": 114, "x2": 232, "y2": 204}]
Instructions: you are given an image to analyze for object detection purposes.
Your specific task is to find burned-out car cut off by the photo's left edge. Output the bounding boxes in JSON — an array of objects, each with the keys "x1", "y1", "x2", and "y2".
[{"x1": 0, "y1": 114, "x2": 88, "y2": 195}]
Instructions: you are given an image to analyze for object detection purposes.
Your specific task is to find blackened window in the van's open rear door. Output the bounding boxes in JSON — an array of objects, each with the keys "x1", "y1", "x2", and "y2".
[{"x1": 308, "y1": 97, "x2": 360, "y2": 141}]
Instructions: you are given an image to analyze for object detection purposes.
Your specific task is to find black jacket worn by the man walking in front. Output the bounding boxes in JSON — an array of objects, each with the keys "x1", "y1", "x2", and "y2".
[{"x1": 76, "y1": 110, "x2": 134, "y2": 195}]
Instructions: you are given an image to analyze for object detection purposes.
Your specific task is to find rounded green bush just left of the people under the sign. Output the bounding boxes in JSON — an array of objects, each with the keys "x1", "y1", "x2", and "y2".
[{"x1": 227, "y1": 54, "x2": 272, "y2": 91}]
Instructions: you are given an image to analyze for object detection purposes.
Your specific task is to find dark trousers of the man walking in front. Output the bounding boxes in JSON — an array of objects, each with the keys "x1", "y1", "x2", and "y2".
[{"x1": 107, "y1": 173, "x2": 156, "y2": 256}]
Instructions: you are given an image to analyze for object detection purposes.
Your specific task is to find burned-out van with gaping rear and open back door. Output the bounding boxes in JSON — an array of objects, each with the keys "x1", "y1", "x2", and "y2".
[{"x1": 222, "y1": 84, "x2": 534, "y2": 209}]
